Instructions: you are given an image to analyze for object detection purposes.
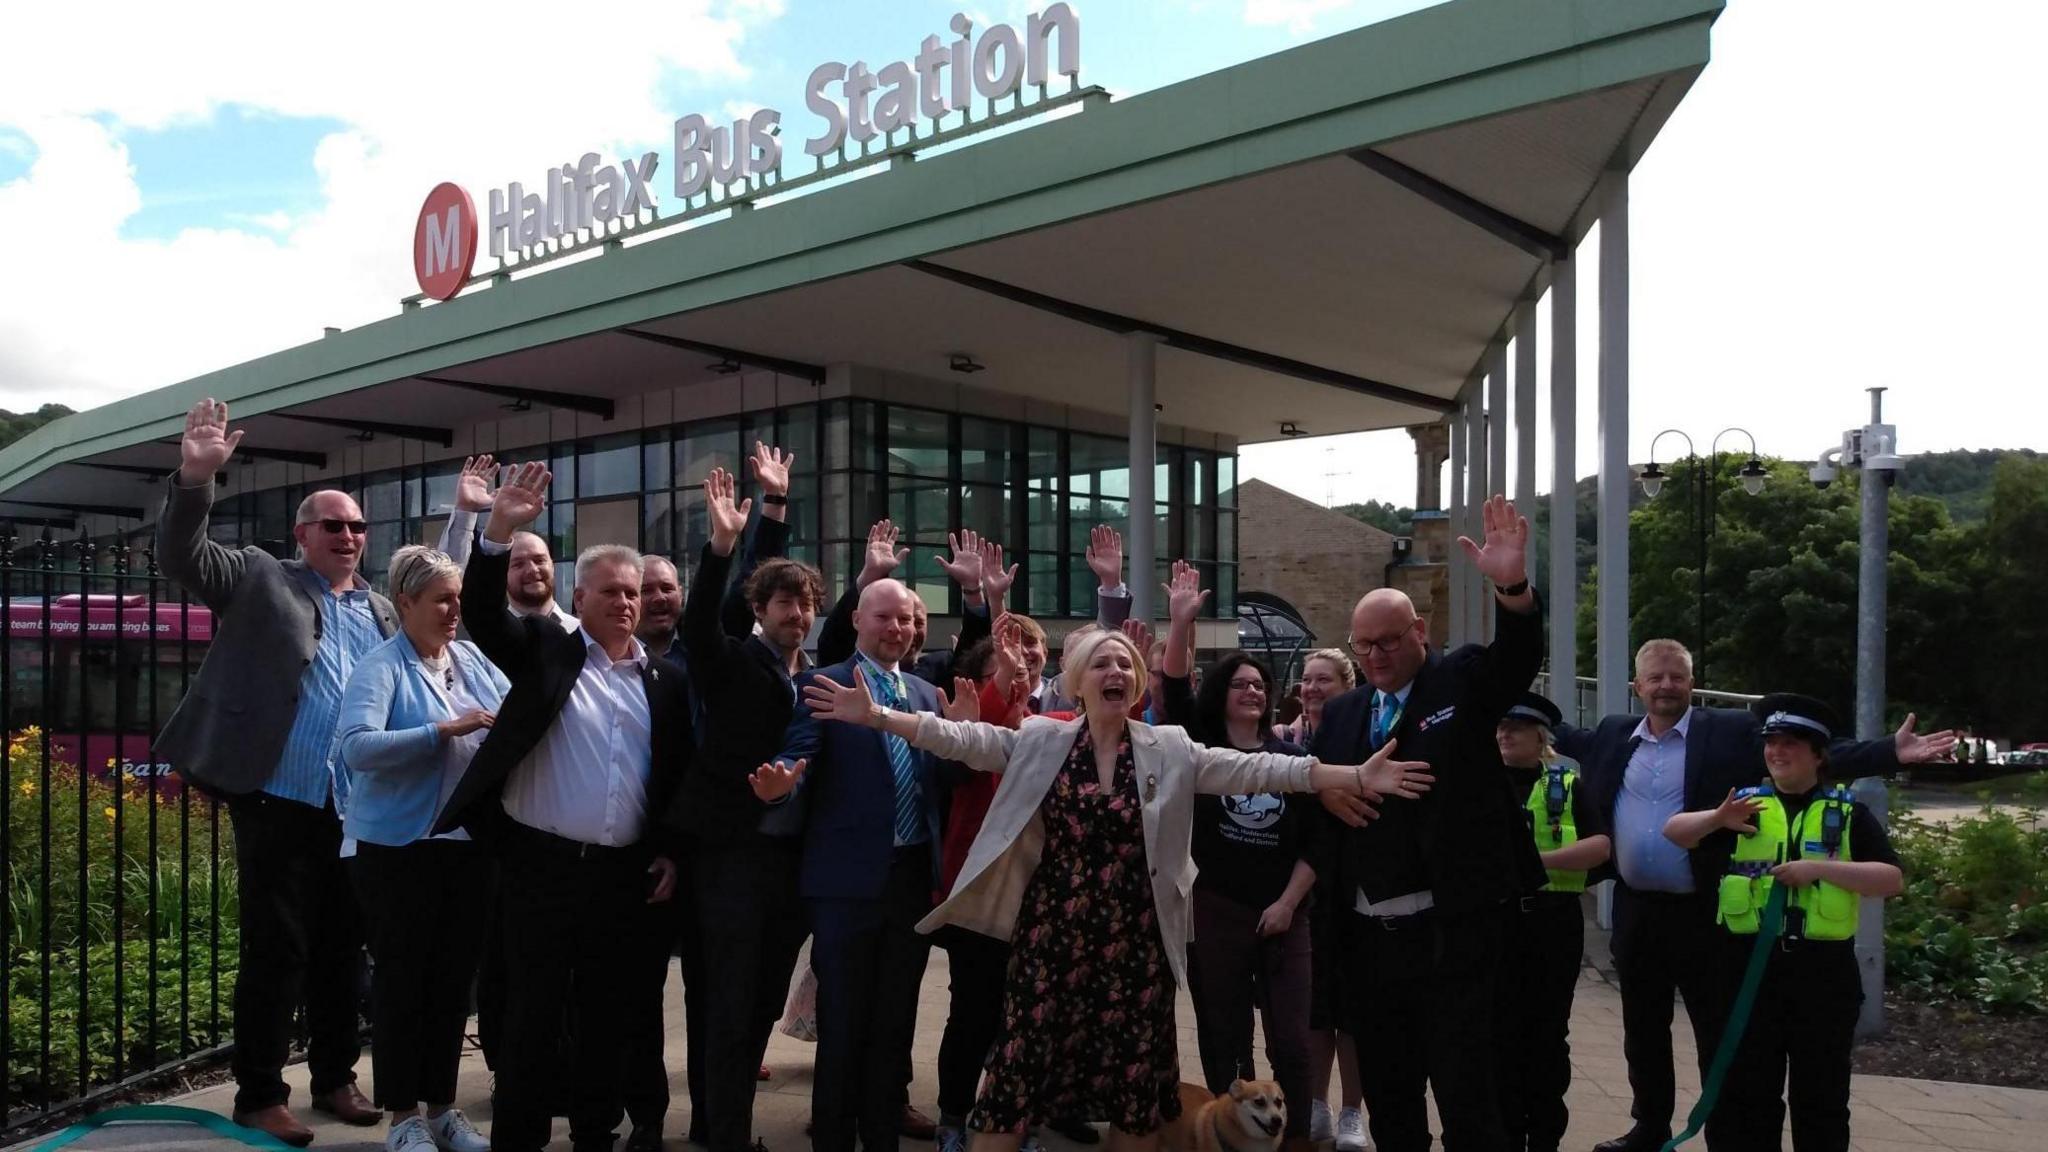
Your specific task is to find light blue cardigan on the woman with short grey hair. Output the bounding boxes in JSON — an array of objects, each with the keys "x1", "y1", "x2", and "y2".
[{"x1": 334, "y1": 631, "x2": 512, "y2": 847}]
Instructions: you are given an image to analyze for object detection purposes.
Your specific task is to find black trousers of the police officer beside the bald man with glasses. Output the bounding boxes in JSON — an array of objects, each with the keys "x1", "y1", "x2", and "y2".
[{"x1": 1493, "y1": 892, "x2": 1585, "y2": 1152}]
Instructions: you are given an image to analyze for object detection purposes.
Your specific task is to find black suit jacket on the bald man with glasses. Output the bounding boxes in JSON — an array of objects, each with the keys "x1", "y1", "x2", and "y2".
[{"x1": 1309, "y1": 594, "x2": 1544, "y2": 912}]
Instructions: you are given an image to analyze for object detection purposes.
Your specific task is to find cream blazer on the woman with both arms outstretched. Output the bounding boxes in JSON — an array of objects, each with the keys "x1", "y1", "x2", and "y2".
[{"x1": 913, "y1": 711, "x2": 1315, "y2": 986}]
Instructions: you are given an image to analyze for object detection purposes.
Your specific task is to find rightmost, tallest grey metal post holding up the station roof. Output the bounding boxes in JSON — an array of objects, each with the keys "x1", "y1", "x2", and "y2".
[{"x1": 1593, "y1": 170, "x2": 1634, "y2": 715}]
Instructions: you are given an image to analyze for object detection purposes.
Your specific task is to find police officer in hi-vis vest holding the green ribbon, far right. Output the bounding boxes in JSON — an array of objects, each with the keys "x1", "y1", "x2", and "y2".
[{"x1": 1665, "y1": 693, "x2": 1905, "y2": 1152}]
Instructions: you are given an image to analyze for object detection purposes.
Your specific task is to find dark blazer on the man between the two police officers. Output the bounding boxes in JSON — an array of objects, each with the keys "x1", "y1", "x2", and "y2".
[{"x1": 1552, "y1": 707, "x2": 1898, "y2": 892}]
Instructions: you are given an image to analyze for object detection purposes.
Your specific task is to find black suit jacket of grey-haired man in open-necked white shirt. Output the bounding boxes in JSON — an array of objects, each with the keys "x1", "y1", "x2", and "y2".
[{"x1": 434, "y1": 547, "x2": 696, "y2": 855}]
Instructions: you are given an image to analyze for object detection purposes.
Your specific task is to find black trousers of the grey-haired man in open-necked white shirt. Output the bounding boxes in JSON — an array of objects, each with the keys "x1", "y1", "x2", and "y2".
[{"x1": 492, "y1": 820, "x2": 662, "y2": 1152}]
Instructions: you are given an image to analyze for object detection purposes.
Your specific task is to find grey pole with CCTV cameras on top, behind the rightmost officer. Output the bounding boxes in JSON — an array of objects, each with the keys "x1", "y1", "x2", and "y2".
[{"x1": 1843, "y1": 387, "x2": 1901, "y2": 1035}]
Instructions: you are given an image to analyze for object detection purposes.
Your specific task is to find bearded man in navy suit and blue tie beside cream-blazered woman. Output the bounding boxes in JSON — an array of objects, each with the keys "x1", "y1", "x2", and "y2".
[{"x1": 778, "y1": 580, "x2": 944, "y2": 1152}]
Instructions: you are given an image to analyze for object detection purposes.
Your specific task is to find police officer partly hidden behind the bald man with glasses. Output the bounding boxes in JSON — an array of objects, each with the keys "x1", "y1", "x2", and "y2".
[{"x1": 1493, "y1": 693, "x2": 1610, "y2": 1152}]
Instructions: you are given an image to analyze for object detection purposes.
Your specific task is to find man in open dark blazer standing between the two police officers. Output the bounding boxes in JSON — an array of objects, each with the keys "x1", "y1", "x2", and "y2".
[{"x1": 1554, "y1": 640, "x2": 1956, "y2": 1152}]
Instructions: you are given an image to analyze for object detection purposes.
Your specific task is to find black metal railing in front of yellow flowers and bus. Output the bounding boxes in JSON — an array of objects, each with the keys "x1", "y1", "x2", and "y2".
[{"x1": 0, "y1": 529, "x2": 238, "y2": 1132}]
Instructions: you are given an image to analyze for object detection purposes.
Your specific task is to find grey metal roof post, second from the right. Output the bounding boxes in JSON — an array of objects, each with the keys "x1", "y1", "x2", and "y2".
[{"x1": 1544, "y1": 258, "x2": 1572, "y2": 709}]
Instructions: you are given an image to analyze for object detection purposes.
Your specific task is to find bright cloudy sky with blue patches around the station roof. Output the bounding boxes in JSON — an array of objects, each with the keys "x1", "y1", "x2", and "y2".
[{"x1": 0, "y1": 0, "x2": 2048, "y2": 504}]
